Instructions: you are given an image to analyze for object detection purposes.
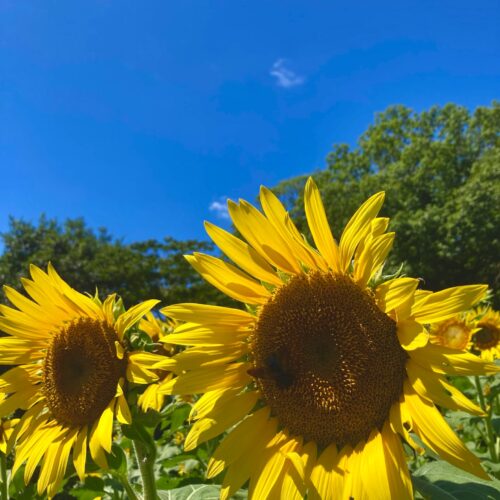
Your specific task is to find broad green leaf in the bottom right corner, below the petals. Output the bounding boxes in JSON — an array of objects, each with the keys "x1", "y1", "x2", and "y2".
[{"x1": 413, "y1": 460, "x2": 500, "y2": 500}]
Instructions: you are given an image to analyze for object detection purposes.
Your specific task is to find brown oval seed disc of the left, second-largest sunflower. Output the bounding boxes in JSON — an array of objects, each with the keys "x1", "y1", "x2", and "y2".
[{"x1": 44, "y1": 318, "x2": 126, "y2": 425}]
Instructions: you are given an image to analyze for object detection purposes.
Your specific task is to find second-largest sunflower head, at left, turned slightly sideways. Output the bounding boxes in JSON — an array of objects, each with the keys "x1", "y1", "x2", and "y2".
[{"x1": 0, "y1": 264, "x2": 169, "y2": 497}]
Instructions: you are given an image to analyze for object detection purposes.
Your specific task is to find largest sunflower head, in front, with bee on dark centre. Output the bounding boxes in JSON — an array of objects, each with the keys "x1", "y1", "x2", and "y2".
[{"x1": 157, "y1": 179, "x2": 497, "y2": 500}]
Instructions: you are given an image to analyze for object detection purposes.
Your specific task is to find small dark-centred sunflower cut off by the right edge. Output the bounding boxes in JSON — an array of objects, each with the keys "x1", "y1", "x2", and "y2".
[{"x1": 472, "y1": 307, "x2": 500, "y2": 361}]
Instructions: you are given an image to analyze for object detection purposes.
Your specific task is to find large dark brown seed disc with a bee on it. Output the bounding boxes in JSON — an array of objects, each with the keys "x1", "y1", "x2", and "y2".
[{"x1": 249, "y1": 272, "x2": 407, "y2": 446}]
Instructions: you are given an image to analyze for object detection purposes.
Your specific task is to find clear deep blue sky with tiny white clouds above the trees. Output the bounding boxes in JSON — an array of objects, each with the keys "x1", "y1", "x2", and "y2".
[{"x1": 0, "y1": 0, "x2": 500, "y2": 241}]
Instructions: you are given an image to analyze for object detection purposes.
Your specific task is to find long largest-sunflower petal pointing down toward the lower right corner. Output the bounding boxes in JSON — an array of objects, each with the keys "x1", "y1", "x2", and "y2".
[{"x1": 404, "y1": 382, "x2": 489, "y2": 479}]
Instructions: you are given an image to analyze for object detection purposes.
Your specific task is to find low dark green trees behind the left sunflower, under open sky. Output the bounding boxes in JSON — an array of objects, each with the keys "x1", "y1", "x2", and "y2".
[{"x1": 0, "y1": 216, "x2": 228, "y2": 306}]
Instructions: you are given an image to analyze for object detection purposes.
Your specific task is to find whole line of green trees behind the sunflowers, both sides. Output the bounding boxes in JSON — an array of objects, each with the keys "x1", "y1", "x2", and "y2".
[{"x1": 0, "y1": 102, "x2": 500, "y2": 307}]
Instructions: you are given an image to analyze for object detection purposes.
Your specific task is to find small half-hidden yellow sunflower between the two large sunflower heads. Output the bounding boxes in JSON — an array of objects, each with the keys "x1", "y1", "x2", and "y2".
[{"x1": 137, "y1": 312, "x2": 175, "y2": 412}]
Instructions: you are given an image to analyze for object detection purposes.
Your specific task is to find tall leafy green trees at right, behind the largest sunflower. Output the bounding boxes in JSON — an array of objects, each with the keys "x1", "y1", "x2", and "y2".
[{"x1": 276, "y1": 102, "x2": 500, "y2": 306}]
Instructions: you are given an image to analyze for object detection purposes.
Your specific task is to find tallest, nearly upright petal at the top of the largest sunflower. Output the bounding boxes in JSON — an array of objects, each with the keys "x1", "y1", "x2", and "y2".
[{"x1": 304, "y1": 177, "x2": 340, "y2": 272}]
